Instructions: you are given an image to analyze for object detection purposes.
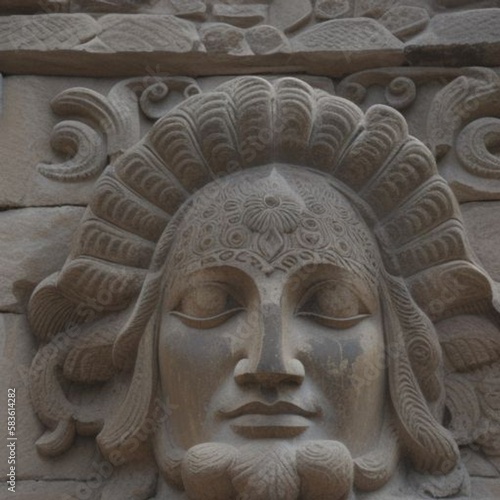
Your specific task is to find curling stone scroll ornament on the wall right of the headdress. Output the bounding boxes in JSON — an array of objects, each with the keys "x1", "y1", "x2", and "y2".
[{"x1": 337, "y1": 68, "x2": 500, "y2": 202}]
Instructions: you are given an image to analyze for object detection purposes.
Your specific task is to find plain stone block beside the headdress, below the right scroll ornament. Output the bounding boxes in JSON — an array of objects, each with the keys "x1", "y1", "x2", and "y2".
[{"x1": 461, "y1": 201, "x2": 500, "y2": 282}]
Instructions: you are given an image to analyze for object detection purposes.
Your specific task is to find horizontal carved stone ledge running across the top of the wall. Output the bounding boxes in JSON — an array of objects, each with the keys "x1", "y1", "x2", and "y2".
[{"x1": 0, "y1": 0, "x2": 500, "y2": 76}]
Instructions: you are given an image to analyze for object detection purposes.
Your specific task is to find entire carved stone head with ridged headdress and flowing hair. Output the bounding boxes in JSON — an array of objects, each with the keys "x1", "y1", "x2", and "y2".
[{"x1": 29, "y1": 76, "x2": 500, "y2": 500}]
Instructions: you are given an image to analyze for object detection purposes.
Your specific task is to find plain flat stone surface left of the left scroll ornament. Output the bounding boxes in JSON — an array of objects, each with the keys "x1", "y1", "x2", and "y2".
[{"x1": 0, "y1": 76, "x2": 119, "y2": 208}]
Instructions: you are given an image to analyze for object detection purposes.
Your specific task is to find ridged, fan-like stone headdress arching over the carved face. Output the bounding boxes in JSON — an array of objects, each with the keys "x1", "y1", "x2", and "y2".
[{"x1": 29, "y1": 77, "x2": 498, "y2": 488}]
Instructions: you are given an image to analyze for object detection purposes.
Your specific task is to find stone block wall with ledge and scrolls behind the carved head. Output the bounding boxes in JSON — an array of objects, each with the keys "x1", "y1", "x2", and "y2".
[{"x1": 0, "y1": 0, "x2": 500, "y2": 500}]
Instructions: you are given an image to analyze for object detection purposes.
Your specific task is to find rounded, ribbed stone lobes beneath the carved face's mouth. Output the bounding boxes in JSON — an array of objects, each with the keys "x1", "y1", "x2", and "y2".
[{"x1": 150, "y1": 408, "x2": 399, "y2": 500}]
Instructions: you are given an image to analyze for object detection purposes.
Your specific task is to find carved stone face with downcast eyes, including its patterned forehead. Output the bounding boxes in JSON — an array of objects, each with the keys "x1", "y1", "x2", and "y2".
[{"x1": 159, "y1": 167, "x2": 386, "y2": 457}]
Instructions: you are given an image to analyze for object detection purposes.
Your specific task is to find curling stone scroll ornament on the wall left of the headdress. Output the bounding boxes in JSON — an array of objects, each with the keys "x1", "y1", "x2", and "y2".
[{"x1": 37, "y1": 75, "x2": 201, "y2": 182}]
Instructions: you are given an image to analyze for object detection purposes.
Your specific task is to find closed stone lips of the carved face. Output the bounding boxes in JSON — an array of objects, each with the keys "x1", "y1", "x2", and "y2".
[{"x1": 220, "y1": 401, "x2": 319, "y2": 439}]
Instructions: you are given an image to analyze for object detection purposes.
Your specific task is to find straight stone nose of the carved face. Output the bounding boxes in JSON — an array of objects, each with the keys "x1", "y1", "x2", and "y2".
[{"x1": 234, "y1": 303, "x2": 305, "y2": 387}]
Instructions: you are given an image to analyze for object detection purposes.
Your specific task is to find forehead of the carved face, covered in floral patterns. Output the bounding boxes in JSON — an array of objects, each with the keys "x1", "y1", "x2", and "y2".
[{"x1": 167, "y1": 166, "x2": 380, "y2": 286}]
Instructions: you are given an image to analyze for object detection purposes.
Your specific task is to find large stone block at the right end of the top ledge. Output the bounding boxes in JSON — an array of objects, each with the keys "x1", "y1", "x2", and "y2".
[{"x1": 405, "y1": 9, "x2": 500, "y2": 66}]
